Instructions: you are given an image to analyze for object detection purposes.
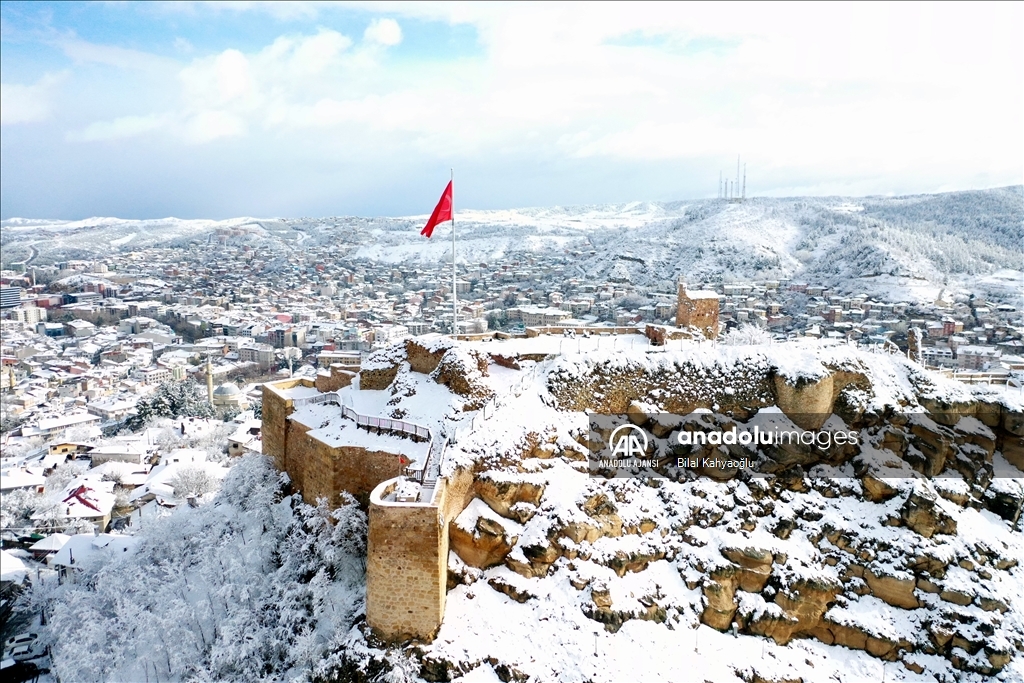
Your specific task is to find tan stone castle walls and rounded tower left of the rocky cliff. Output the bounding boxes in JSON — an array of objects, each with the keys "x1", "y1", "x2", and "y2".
[{"x1": 263, "y1": 352, "x2": 479, "y2": 642}]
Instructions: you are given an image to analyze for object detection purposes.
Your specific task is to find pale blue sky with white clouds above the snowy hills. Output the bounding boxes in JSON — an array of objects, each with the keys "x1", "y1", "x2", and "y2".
[{"x1": 0, "y1": 2, "x2": 1024, "y2": 218}]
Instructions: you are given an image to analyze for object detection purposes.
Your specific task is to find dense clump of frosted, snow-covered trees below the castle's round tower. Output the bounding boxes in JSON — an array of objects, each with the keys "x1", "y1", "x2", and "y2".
[{"x1": 34, "y1": 455, "x2": 367, "y2": 681}]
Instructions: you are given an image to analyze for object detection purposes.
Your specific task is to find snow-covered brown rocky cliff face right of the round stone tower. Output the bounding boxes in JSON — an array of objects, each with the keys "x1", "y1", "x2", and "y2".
[{"x1": 403, "y1": 344, "x2": 1024, "y2": 680}]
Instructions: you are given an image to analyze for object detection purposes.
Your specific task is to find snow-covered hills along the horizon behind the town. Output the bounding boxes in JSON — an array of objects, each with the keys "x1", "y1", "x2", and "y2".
[{"x1": 2, "y1": 186, "x2": 1024, "y2": 299}]
